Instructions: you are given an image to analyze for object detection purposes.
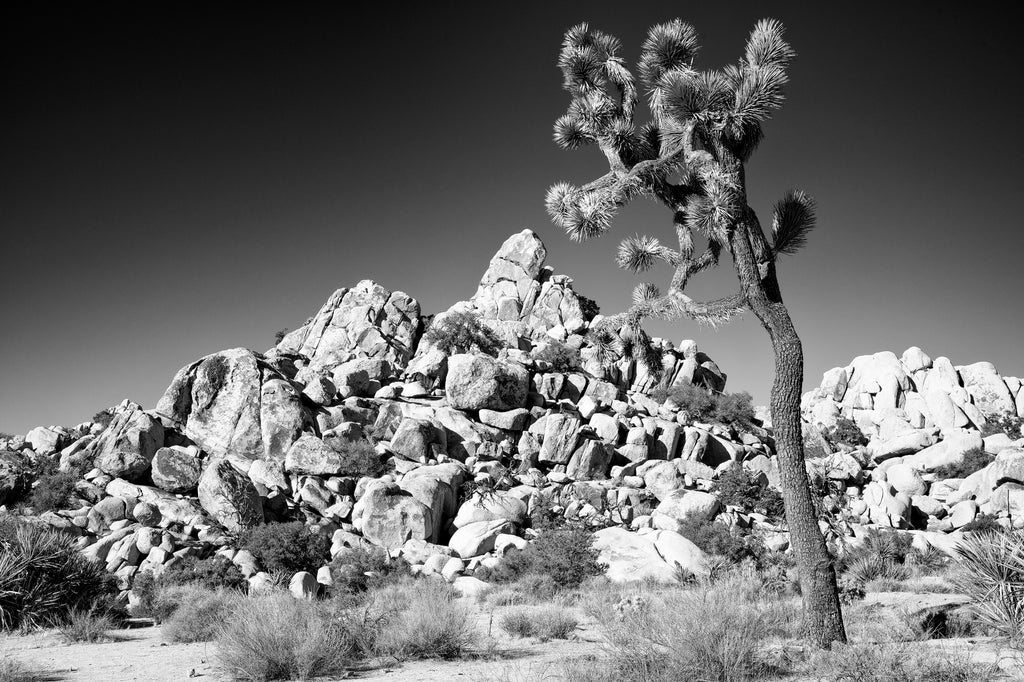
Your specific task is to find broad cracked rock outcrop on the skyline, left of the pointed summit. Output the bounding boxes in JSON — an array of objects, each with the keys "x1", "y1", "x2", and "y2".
[{"x1": 276, "y1": 280, "x2": 421, "y2": 372}]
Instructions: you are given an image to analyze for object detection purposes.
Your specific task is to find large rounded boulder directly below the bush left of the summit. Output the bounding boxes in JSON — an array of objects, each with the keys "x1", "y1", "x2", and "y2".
[{"x1": 444, "y1": 353, "x2": 529, "y2": 411}]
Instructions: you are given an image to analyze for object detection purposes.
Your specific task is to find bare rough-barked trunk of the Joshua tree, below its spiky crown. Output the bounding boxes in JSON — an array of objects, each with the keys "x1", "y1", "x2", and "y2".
[{"x1": 730, "y1": 220, "x2": 846, "y2": 648}]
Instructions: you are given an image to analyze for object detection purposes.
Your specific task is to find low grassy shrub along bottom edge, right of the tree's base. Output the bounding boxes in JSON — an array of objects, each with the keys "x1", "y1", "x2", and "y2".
[{"x1": 805, "y1": 643, "x2": 998, "y2": 682}]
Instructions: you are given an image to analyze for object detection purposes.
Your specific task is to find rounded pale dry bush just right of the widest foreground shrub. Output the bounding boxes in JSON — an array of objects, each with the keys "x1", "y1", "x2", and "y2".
[{"x1": 377, "y1": 581, "x2": 475, "y2": 659}]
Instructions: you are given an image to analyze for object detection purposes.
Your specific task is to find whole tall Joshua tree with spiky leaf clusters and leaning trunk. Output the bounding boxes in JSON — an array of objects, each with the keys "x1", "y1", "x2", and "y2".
[{"x1": 547, "y1": 19, "x2": 846, "y2": 646}]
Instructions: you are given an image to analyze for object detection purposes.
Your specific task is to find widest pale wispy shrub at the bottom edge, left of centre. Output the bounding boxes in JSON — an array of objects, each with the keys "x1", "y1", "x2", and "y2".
[{"x1": 217, "y1": 592, "x2": 366, "y2": 681}]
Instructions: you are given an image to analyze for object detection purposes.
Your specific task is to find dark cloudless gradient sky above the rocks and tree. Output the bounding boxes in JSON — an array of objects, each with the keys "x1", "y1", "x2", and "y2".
[{"x1": 0, "y1": 2, "x2": 1024, "y2": 432}]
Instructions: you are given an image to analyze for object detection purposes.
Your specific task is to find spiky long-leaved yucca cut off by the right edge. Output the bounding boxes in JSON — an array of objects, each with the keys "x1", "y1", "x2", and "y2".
[{"x1": 952, "y1": 530, "x2": 1024, "y2": 640}]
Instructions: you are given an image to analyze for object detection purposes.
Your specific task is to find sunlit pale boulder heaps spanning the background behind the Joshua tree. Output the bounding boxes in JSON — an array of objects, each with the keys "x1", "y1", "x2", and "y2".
[{"x1": 0, "y1": 230, "x2": 1024, "y2": 594}]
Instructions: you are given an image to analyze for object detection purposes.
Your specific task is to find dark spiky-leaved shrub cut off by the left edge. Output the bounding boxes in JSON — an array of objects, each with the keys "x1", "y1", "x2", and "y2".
[{"x1": 0, "y1": 517, "x2": 117, "y2": 630}]
